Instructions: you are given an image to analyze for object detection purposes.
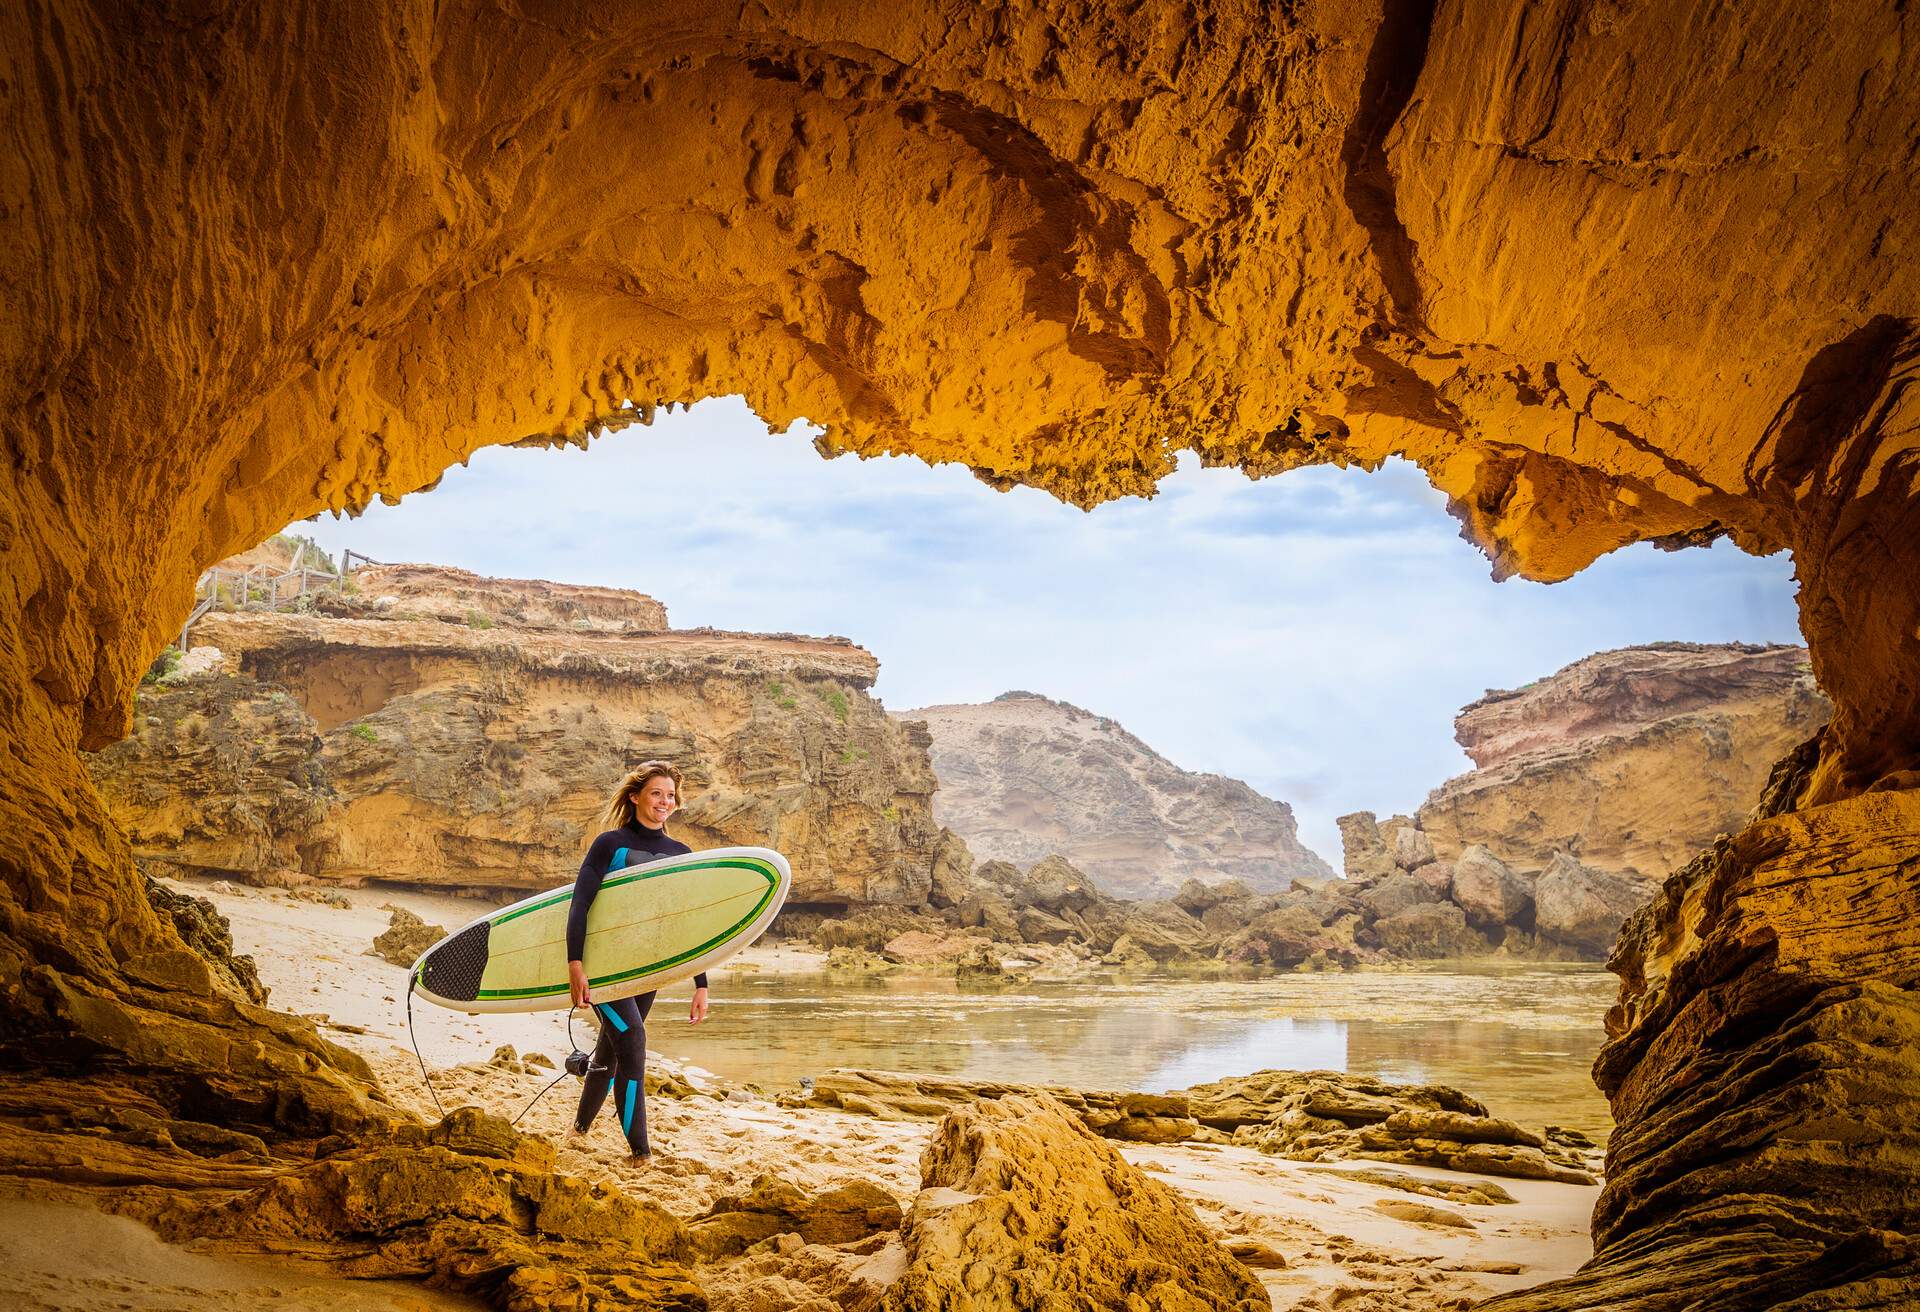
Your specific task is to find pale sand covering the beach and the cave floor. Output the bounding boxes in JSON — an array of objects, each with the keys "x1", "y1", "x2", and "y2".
[{"x1": 15, "y1": 880, "x2": 1597, "y2": 1312}]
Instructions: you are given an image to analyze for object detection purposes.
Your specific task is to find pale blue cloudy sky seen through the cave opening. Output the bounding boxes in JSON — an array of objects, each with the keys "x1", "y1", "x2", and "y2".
[{"x1": 294, "y1": 398, "x2": 1801, "y2": 868}]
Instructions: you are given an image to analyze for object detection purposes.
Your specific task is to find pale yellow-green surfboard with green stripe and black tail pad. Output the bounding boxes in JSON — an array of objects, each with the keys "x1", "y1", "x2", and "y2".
[{"x1": 409, "y1": 847, "x2": 793, "y2": 1014}]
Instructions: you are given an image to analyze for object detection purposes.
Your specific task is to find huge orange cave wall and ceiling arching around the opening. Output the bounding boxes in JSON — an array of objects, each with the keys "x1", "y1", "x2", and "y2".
[{"x1": 0, "y1": 0, "x2": 1920, "y2": 1308}]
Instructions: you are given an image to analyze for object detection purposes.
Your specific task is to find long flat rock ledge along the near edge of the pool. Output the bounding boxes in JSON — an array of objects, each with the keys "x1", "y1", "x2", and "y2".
[{"x1": 781, "y1": 1070, "x2": 1601, "y2": 1185}]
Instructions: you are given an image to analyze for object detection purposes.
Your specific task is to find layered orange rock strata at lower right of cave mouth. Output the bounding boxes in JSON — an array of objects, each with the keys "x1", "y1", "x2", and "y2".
[{"x1": 1486, "y1": 760, "x2": 1920, "y2": 1312}]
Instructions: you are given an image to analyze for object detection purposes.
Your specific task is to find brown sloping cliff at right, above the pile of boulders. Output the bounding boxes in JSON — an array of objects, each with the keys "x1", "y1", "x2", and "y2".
[{"x1": 1415, "y1": 644, "x2": 1830, "y2": 880}]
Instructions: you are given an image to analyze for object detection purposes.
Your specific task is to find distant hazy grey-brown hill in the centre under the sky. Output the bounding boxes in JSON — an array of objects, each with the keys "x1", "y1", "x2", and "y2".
[{"x1": 900, "y1": 692, "x2": 1332, "y2": 897}]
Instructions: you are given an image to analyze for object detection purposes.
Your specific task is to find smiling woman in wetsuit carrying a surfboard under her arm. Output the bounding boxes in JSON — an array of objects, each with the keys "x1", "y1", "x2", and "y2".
[{"x1": 566, "y1": 761, "x2": 707, "y2": 1162}]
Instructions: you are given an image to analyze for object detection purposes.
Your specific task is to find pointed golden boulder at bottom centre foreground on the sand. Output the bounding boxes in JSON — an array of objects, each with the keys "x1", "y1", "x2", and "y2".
[{"x1": 881, "y1": 1095, "x2": 1271, "y2": 1312}]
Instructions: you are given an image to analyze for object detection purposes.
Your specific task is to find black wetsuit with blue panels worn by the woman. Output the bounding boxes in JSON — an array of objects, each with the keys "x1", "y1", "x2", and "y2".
[{"x1": 566, "y1": 820, "x2": 707, "y2": 1156}]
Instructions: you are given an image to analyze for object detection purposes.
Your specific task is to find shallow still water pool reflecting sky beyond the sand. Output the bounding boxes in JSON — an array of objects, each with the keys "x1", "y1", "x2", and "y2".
[{"x1": 649, "y1": 966, "x2": 1617, "y2": 1133}]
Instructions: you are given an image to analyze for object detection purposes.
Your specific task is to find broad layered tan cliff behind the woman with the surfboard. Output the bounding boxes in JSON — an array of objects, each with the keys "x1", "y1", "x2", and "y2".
[{"x1": 88, "y1": 567, "x2": 939, "y2": 905}]
